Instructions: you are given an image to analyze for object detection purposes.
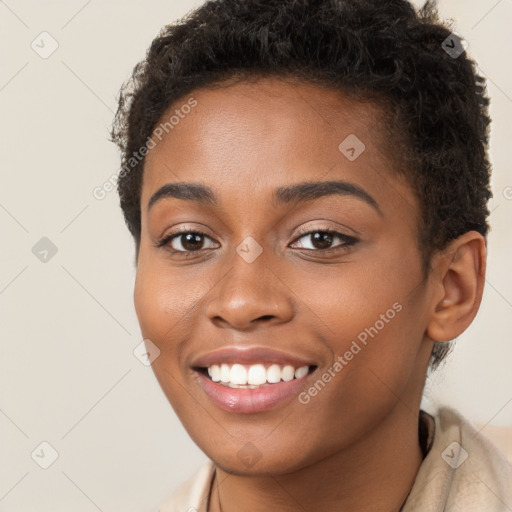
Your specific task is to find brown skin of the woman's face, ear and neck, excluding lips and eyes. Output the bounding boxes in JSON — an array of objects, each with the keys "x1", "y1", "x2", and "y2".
[{"x1": 134, "y1": 79, "x2": 485, "y2": 512}]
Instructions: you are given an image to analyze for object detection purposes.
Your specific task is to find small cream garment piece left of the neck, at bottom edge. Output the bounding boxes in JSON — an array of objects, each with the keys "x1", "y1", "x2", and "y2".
[{"x1": 158, "y1": 460, "x2": 215, "y2": 512}]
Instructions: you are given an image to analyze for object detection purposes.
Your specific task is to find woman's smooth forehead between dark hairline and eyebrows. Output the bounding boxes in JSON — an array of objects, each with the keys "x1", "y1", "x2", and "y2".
[{"x1": 141, "y1": 78, "x2": 412, "y2": 216}]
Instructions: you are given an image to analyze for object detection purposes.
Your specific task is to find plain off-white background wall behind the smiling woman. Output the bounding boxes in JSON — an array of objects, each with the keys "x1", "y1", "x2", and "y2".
[{"x1": 0, "y1": 0, "x2": 512, "y2": 512}]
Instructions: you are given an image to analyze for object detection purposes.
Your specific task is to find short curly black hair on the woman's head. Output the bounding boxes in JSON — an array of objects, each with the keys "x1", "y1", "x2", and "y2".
[{"x1": 111, "y1": 0, "x2": 492, "y2": 368}]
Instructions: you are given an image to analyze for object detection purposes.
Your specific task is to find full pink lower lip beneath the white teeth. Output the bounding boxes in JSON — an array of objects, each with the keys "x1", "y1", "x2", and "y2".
[{"x1": 197, "y1": 372, "x2": 313, "y2": 414}]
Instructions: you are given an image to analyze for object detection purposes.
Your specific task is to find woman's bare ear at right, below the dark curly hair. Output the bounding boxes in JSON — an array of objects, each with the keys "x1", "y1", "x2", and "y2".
[{"x1": 427, "y1": 231, "x2": 487, "y2": 341}]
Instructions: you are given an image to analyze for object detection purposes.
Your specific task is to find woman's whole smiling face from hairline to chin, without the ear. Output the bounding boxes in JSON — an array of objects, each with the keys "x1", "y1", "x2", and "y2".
[{"x1": 134, "y1": 79, "x2": 432, "y2": 474}]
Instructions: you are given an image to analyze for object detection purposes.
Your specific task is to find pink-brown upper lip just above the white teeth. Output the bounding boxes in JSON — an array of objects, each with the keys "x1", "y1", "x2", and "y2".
[{"x1": 191, "y1": 346, "x2": 314, "y2": 368}]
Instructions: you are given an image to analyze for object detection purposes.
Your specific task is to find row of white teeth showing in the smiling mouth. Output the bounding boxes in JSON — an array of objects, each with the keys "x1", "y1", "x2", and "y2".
[{"x1": 208, "y1": 363, "x2": 309, "y2": 389}]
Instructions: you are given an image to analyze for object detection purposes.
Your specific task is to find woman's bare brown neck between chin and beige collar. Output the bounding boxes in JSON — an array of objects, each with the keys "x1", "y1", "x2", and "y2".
[{"x1": 208, "y1": 402, "x2": 422, "y2": 512}]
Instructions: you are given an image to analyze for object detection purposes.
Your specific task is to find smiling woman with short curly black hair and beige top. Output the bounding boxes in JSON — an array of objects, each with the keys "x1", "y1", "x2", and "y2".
[{"x1": 112, "y1": 0, "x2": 512, "y2": 512}]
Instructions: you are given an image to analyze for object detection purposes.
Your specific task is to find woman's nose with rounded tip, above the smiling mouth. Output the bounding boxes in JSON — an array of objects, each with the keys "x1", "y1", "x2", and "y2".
[{"x1": 206, "y1": 247, "x2": 294, "y2": 332}]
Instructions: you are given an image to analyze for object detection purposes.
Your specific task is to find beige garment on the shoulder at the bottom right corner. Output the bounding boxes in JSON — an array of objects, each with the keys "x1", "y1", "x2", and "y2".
[{"x1": 404, "y1": 407, "x2": 512, "y2": 512}]
